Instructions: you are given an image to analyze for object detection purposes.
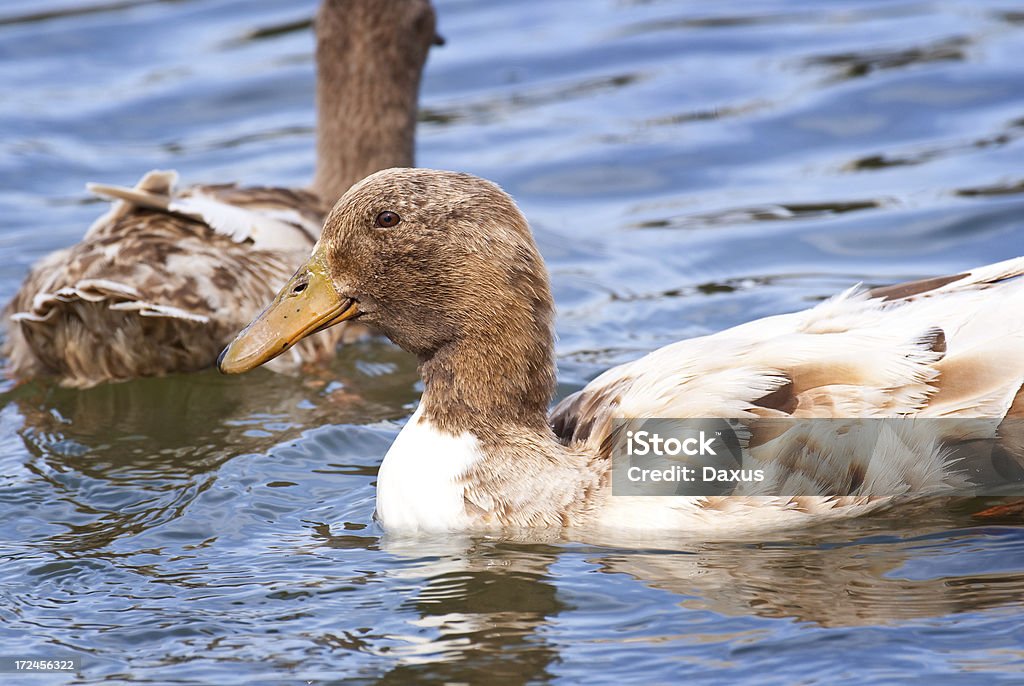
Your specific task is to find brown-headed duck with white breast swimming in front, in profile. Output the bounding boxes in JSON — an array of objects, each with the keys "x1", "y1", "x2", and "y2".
[{"x1": 218, "y1": 168, "x2": 1024, "y2": 538}]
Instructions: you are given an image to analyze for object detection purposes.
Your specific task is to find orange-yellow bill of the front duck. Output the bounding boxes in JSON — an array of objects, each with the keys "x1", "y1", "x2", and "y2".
[{"x1": 217, "y1": 251, "x2": 360, "y2": 374}]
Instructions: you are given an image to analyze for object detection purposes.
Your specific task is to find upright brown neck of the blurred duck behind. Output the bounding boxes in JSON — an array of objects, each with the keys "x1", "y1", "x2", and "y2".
[{"x1": 313, "y1": 0, "x2": 435, "y2": 204}]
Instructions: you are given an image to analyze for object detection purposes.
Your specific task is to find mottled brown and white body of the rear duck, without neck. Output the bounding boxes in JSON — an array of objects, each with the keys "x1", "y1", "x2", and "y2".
[{"x1": 7, "y1": 171, "x2": 335, "y2": 387}]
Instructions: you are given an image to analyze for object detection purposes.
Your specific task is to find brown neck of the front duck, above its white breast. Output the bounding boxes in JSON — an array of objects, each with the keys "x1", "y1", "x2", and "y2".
[{"x1": 420, "y1": 319, "x2": 555, "y2": 443}]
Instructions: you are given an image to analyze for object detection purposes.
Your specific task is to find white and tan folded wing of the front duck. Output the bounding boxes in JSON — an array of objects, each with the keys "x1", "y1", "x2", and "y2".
[{"x1": 551, "y1": 258, "x2": 1024, "y2": 509}]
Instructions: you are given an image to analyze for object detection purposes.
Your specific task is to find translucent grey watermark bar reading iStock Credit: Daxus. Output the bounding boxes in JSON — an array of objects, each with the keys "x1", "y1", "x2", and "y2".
[{"x1": 609, "y1": 418, "x2": 1024, "y2": 497}]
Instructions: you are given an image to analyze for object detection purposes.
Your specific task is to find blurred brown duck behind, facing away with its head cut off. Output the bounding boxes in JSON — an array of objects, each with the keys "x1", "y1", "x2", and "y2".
[{"x1": 4, "y1": 0, "x2": 442, "y2": 388}]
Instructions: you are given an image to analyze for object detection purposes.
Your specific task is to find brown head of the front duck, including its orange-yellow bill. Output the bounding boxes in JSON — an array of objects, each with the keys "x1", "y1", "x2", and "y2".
[{"x1": 218, "y1": 169, "x2": 553, "y2": 395}]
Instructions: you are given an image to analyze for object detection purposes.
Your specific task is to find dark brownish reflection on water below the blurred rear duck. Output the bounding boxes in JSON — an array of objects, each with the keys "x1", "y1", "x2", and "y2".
[{"x1": 5, "y1": 341, "x2": 417, "y2": 551}]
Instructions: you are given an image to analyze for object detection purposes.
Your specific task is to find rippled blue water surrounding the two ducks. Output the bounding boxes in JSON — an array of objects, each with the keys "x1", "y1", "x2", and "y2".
[{"x1": 0, "y1": 0, "x2": 1024, "y2": 685}]
